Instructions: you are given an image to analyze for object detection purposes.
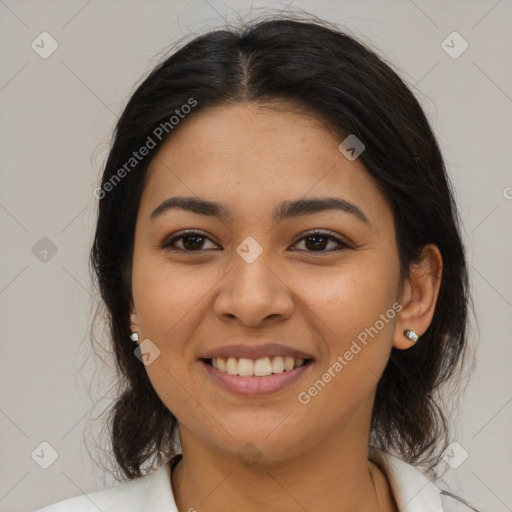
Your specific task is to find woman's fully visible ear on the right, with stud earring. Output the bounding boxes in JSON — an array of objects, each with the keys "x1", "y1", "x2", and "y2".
[{"x1": 393, "y1": 244, "x2": 443, "y2": 350}]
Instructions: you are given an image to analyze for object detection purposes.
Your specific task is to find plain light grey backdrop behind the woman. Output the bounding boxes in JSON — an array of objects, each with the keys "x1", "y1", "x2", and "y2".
[{"x1": 0, "y1": 0, "x2": 512, "y2": 512}]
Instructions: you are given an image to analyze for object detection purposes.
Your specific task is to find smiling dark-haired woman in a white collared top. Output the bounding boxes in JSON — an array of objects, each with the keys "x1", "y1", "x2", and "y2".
[{"x1": 35, "y1": 12, "x2": 474, "y2": 512}]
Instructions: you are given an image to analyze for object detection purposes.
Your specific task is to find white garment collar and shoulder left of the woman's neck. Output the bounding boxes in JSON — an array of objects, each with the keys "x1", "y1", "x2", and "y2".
[{"x1": 35, "y1": 463, "x2": 177, "y2": 512}]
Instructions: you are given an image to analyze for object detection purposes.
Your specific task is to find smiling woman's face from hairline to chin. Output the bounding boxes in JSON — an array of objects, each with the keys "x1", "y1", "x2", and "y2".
[{"x1": 132, "y1": 103, "x2": 408, "y2": 460}]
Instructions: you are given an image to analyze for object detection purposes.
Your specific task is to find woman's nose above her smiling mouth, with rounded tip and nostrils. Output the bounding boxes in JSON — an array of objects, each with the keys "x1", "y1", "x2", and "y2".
[{"x1": 213, "y1": 250, "x2": 294, "y2": 327}]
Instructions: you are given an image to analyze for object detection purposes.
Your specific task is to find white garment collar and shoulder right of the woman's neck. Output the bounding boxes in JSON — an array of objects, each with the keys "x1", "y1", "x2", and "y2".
[{"x1": 370, "y1": 448, "x2": 476, "y2": 512}]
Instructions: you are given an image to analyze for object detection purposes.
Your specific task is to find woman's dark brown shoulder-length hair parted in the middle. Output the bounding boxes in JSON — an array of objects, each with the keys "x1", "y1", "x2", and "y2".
[{"x1": 90, "y1": 10, "x2": 469, "y2": 486}]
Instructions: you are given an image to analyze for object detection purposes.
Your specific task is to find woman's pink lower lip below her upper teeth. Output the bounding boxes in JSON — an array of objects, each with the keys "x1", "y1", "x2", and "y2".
[{"x1": 199, "y1": 361, "x2": 313, "y2": 397}]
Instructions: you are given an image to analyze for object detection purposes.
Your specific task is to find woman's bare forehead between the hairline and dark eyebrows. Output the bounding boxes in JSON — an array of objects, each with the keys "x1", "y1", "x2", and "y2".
[{"x1": 141, "y1": 103, "x2": 390, "y2": 226}]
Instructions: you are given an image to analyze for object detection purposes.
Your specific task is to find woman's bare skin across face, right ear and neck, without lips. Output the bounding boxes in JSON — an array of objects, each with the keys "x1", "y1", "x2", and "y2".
[{"x1": 131, "y1": 103, "x2": 442, "y2": 512}]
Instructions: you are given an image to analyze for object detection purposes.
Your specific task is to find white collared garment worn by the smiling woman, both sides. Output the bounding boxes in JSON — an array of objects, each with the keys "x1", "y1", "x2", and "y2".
[{"x1": 36, "y1": 450, "x2": 472, "y2": 512}]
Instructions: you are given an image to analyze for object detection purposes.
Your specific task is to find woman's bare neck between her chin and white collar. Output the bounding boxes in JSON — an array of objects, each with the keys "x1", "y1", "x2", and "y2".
[{"x1": 172, "y1": 427, "x2": 397, "y2": 512}]
